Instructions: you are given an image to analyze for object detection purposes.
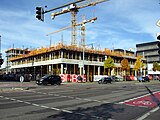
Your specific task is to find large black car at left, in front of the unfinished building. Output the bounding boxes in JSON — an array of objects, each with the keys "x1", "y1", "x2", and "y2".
[{"x1": 36, "y1": 75, "x2": 62, "y2": 85}]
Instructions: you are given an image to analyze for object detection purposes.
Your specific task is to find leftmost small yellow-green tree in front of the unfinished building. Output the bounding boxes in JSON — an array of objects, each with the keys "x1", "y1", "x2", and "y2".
[{"x1": 104, "y1": 56, "x2": 114, "y2": 75}]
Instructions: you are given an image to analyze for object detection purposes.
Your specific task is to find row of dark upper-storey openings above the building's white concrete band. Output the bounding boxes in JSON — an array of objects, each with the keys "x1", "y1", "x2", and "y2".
[{"x1": 12, "y1": 51, "x2": 135, "y2": 65}]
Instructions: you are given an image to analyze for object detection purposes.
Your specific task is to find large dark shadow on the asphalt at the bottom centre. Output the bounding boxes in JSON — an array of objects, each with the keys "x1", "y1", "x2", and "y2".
[{"x1": 46, "y1": 103, "x2": 125, "y2": 120}]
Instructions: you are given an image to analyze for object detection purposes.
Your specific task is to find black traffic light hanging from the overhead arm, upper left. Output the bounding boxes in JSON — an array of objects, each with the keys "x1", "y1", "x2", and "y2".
[{"x1": 36, "y1": 7, "x2": 44, "y2": 21}]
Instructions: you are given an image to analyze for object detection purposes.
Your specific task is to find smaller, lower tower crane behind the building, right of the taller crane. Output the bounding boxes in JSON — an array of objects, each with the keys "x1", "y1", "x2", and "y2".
[{"x1": 46, "y1": 15, "x2": 97, "y2": 46}]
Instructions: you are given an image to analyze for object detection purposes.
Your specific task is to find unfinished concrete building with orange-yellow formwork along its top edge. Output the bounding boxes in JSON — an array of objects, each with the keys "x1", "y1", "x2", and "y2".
[{"x1": 5, "y1": 43, "x2": 145, "y2": 81}]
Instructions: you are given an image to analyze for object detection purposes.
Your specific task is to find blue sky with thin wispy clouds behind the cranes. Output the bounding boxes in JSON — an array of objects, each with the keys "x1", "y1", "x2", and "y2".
[{"x1": 0, "y1": 0, "x2": 160, "y2": 66}]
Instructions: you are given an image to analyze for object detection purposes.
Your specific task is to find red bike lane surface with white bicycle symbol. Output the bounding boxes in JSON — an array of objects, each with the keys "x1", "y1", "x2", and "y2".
[{"x1": 120, "y1": 91, "x2": 160, "y2": 108}]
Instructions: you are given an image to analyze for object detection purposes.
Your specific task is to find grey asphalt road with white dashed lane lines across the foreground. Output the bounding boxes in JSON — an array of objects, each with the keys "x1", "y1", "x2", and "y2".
[{"x1": 0, "y1": 82, "x2": 160, "y2": 120}]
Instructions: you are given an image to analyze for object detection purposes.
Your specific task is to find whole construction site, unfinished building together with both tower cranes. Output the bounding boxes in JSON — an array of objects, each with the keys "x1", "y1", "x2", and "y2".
[{"x1": 5, "y1": 0, "x2": 145, "y2": 82}]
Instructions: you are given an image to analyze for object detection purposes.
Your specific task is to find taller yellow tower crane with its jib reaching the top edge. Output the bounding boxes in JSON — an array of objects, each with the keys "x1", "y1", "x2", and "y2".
[{"x1": 50, "y1": 0, "x2": 108, "y2": 45}]
